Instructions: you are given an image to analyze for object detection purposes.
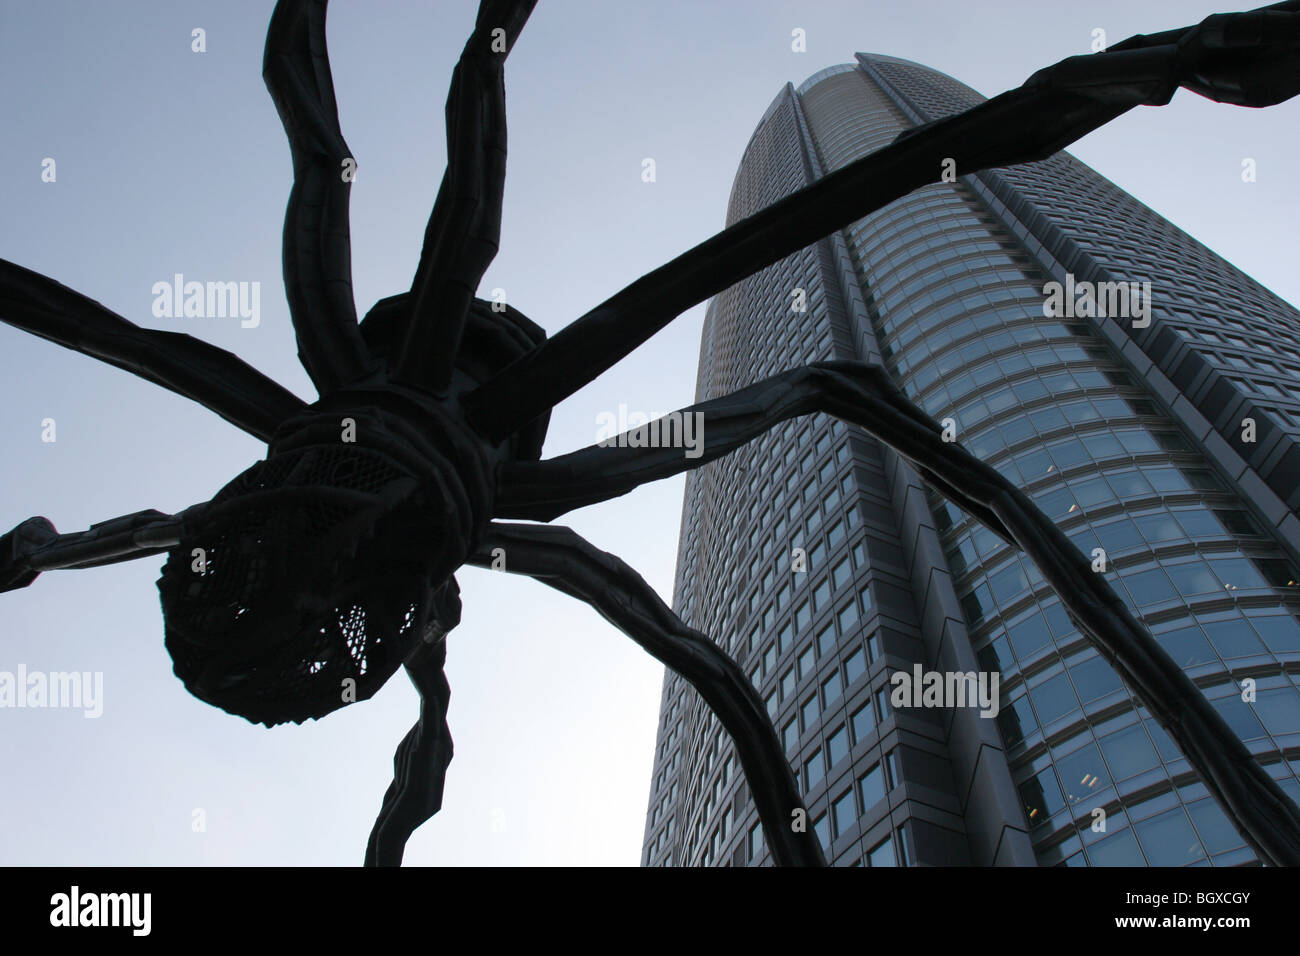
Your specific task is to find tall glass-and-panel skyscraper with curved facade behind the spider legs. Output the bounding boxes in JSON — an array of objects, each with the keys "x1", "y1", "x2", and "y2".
[{"x1": 642, "y1": 53, "x2": 1300, "y2": 866}]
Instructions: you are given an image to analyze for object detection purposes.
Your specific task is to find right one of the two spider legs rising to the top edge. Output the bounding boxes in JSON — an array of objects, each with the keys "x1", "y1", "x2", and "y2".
[{"x1": 394, "y1": 0, "x2": 537, "y2": 392}]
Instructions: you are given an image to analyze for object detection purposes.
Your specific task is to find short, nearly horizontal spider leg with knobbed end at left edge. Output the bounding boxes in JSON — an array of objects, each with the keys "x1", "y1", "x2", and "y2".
[{"x1": 0, "y1": 503, "x2": 207, "y2": 592}]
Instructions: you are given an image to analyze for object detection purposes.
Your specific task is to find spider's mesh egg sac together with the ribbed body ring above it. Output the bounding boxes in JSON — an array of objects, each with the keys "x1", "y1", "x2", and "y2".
[{"x1": 159, "y1": 389, "x2": 491, "y2": 724}]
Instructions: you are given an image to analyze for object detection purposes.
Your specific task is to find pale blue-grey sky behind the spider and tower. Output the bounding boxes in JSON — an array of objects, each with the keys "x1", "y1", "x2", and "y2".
[{"x1": 0, "y1": 0, "x2": 1300, "y2": 865}]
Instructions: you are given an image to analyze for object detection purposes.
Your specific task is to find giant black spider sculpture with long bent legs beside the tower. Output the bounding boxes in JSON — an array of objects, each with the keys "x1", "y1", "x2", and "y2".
[{"x1": 0, "y1": 0, "x2": 1300, "y2": 865}]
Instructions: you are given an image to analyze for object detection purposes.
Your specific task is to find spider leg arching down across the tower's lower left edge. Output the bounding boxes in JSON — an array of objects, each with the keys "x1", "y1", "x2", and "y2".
[{"x1": 468, "y1": 522, "x2": 826, "y2": 866}]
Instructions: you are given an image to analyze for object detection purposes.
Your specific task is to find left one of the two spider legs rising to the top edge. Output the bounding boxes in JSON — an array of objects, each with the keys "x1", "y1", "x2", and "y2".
[{"x1": 261, "y1": 0, "x2": 374, "y2": 395}]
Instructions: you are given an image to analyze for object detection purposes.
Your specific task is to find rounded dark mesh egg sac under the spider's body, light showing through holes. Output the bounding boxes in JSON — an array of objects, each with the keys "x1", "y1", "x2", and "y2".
[{"x1": 159, "y1": 446, "x2": 442, "y2": 724}]
